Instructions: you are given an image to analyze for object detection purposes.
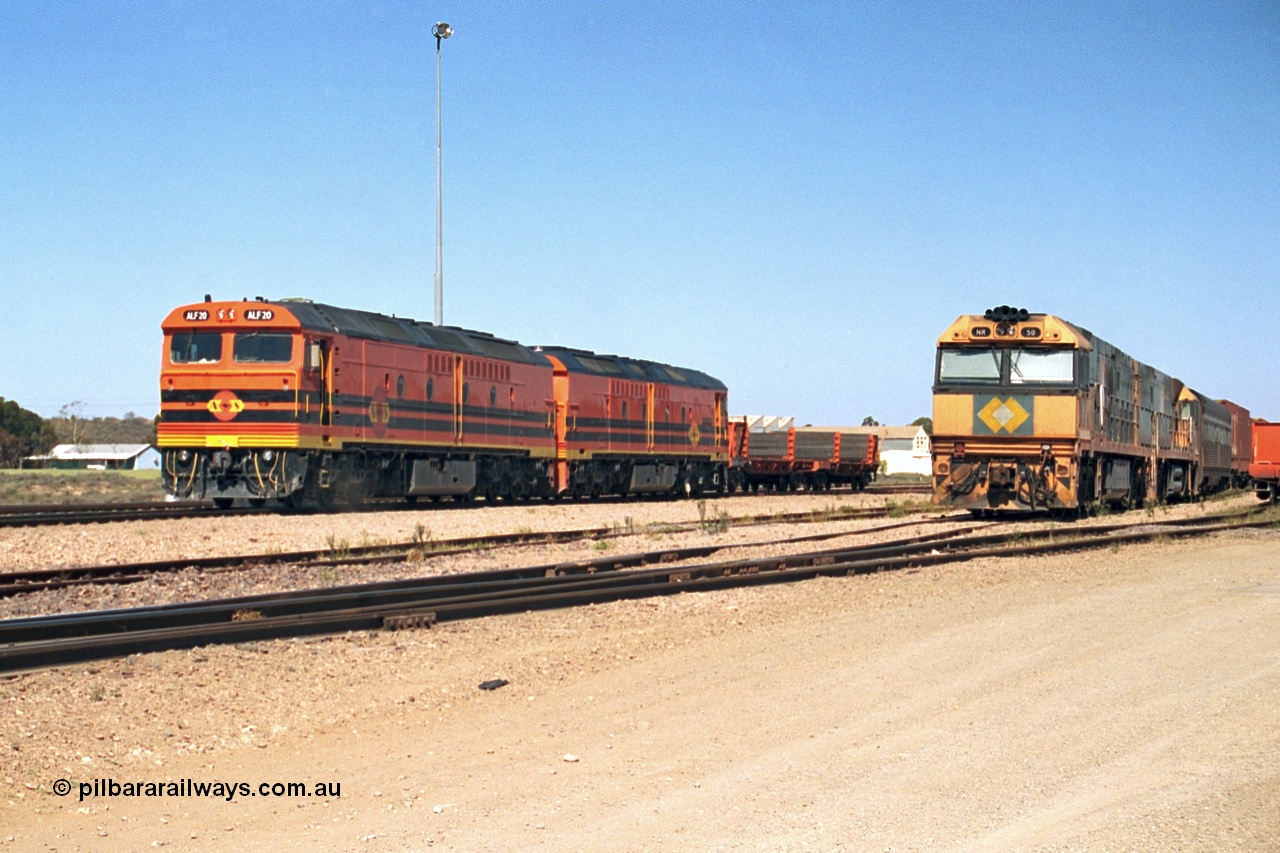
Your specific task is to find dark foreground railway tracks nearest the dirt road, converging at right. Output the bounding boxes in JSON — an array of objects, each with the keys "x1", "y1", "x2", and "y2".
[{"x1": 0, "y1": 504, "x2": 1276, "y2": 671}]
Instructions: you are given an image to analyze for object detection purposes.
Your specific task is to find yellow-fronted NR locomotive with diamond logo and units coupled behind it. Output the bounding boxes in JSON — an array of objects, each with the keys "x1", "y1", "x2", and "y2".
[{"x1": 933, "y1": 306, "x2": 1249, "y2": 512}]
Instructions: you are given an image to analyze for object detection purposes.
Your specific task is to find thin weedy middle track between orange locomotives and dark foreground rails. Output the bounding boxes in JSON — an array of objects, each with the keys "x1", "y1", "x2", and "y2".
[{"x1": 0, "y1": 507, "x2": 942, "y2": 598}]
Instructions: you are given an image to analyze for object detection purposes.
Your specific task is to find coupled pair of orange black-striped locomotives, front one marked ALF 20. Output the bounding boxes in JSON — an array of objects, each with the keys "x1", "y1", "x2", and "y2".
[{"x1": 156, "y1": 296, "x2": 728, "y2": 507}]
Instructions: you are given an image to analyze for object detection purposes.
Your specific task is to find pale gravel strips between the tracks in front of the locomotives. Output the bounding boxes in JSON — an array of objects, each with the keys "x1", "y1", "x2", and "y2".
[{"x1": 0, "y1": 493, "x2": 1256, "y2": 619}]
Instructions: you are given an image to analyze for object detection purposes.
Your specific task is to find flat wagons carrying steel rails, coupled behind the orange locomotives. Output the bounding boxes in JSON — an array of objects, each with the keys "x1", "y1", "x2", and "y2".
[{"x1": 728, "y1": 418, "x2": 879, "y2": 492}]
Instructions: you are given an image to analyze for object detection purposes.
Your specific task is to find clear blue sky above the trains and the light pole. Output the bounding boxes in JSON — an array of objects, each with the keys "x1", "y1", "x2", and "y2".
[{"x1": 0, "y1": 0, "x2": 1280, "y2": 424}]
